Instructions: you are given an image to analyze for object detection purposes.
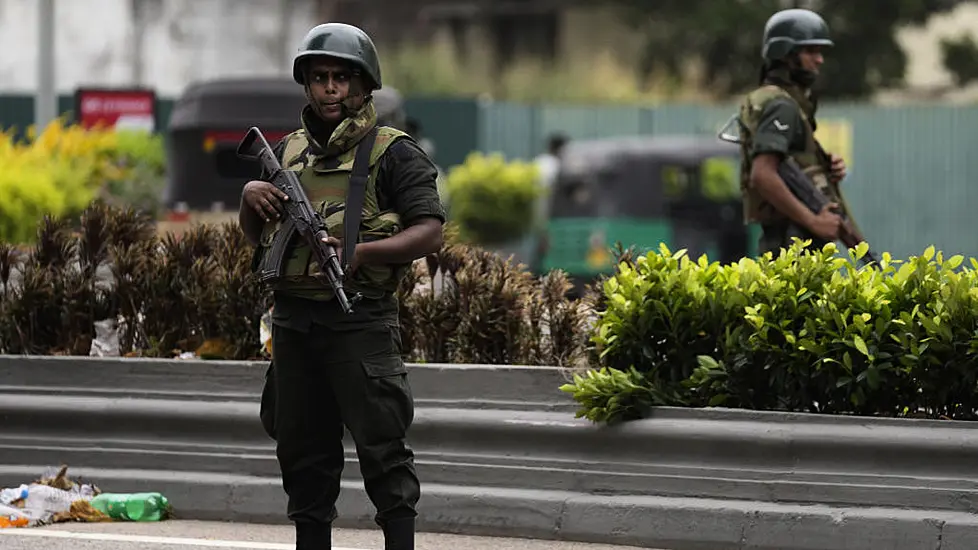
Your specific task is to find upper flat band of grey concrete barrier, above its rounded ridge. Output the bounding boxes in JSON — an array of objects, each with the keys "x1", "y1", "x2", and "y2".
[{"x1": 0, "y1": 355, "x2": 576, "y2": 411}]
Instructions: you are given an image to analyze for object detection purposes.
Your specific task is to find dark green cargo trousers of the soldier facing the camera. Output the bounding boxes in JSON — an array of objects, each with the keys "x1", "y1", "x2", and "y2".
[{"x1": 261, "y1": 306, "x2": 421, "y2": 526}]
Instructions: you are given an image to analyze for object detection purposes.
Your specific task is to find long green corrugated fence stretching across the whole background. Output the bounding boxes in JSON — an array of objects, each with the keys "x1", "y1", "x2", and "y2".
[{"x1": 7, "y1": 94, "x2": 978, "y2": 257}]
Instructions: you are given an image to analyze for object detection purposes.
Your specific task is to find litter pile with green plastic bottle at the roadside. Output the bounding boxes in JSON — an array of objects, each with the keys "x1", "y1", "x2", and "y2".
[{"x1": 0, "y1": 466, "x2": 170, "y2": 529}]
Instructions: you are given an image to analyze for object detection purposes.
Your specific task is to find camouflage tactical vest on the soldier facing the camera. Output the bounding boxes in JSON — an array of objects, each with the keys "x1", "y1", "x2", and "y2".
[{"x1": 256, "y1": 126, "x2": 410, "y2": 301}]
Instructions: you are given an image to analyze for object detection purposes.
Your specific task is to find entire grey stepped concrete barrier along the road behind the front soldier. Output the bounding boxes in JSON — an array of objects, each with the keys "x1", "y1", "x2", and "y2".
[{"x1": 0, "y1": 357, "x2": 978, "y2": 550}]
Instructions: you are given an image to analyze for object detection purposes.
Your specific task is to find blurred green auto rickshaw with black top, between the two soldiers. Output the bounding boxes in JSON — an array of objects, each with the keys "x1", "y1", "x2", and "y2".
[{"x1": 538, "y1": 136, "x2": 757, "y2": 296}]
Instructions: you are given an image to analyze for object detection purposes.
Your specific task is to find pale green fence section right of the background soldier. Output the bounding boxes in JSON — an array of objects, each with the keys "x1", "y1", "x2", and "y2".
[{"x1": 821, "y1": 106, "x2": 978, "y2": 257}]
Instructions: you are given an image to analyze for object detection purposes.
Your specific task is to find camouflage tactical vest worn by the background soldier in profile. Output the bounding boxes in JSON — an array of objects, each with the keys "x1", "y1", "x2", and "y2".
[{"x1": 740, "y1": 84, "x2": 839, "y2": 223}]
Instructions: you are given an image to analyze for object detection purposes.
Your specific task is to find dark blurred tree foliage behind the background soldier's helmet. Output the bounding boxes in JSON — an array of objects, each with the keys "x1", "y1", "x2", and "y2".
[{"x1": 615, "y1": 0, "x2": 963, "y2": 99}]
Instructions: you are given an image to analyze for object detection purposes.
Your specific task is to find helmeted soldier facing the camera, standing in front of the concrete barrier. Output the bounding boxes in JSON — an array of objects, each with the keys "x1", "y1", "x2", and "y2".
[{"x1": 239, "y1": 23, "x2": 445, "y2": 550}]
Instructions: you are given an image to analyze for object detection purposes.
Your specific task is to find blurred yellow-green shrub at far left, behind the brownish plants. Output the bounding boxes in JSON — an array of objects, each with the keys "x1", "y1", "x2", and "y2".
[{"x1": 0, "y1": 120, "x2": 165, "y2": 244}]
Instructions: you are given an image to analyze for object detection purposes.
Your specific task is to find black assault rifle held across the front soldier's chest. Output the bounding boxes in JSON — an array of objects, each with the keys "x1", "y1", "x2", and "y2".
[{"x1": 237, "y1": 127, "x2": 361, "y2": 313}]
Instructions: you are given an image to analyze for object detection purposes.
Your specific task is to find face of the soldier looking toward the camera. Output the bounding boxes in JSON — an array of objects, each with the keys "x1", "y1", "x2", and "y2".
[{"x1": 306, "y1": 58, "x2": 363, "y2": 123}]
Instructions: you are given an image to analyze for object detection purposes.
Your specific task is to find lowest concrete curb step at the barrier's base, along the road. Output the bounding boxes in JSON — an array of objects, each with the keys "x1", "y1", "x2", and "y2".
[{"x1": 0, "y1": 466, "x2": 978, "y2": 550}]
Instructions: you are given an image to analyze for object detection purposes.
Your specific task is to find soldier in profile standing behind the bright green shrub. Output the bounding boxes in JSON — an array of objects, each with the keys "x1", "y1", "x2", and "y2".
[{"x1": 740, "y1": 9, "x2": 846, "y2": 255}]
